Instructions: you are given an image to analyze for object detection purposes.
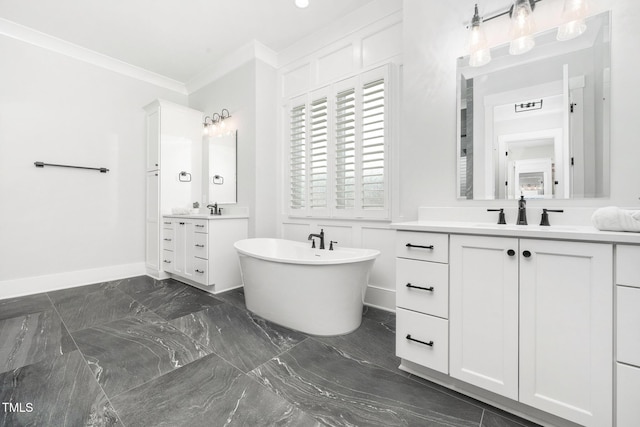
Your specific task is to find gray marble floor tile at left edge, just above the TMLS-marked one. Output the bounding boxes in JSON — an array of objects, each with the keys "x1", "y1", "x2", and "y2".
[{"x1": 0, "y1": 308, "x2": 77, "y2": 372}]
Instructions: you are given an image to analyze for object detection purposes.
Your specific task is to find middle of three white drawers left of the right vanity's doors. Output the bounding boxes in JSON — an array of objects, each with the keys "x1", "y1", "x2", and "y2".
[{"x1": 396, "y1": 258, "x2": 449, "y2": 319}]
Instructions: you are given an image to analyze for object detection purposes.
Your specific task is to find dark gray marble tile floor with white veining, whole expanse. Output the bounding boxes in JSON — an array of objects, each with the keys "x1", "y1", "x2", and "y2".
[{"x1": 0, "y1": 276, "x2": 534, "y2": 427}]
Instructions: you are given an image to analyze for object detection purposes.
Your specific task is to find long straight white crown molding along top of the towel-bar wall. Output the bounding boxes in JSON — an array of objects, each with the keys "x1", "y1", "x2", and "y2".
[{"x1": 0, "y1": 18, "x2": 188, "y2": 95}]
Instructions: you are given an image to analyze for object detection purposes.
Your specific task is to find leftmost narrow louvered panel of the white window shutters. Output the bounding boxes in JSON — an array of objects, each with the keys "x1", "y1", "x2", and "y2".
[{"x1": 289, "y1": 104, "x2": 307, "y2": 212}]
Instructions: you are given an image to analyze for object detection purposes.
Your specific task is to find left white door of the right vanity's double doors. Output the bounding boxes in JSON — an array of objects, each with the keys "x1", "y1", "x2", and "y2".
[{"x1": 449, "y1": 236, "x2": 518, "y2": 399}]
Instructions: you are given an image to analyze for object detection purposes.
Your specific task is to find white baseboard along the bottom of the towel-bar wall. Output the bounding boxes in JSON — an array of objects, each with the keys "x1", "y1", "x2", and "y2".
[{"x1": 0, "y1": 262, "x2": 146, "y2": 300}]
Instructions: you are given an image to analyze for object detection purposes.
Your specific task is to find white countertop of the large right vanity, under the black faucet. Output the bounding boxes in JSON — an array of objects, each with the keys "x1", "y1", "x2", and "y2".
[{"x1": 391, "y1": 221, "x2": 640, "y2": 244}]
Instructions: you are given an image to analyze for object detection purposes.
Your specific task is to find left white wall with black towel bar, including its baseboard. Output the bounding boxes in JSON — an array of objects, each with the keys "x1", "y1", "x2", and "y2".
[{"x1": 0, "y1": 36, "x2": 186, "y2": 298}]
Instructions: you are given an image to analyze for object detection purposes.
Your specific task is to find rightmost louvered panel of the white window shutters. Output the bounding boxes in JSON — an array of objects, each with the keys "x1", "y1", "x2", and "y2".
[{"x1": 361, "y1": 79, "x2": 386, "y2": 210}]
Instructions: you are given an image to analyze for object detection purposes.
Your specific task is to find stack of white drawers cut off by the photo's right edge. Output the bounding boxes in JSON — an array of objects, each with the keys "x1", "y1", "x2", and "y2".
[{"x1": 616, "y1": 245, "x2": 640, "y2": 427}]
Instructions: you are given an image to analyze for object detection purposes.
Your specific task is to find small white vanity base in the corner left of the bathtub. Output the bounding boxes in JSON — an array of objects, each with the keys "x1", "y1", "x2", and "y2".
[{"x1": 162, "y1": 216, "x2": 248, "y2": 293}]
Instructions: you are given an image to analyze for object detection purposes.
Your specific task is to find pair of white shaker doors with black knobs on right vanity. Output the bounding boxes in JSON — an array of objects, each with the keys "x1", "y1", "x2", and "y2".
[{"x1": 449, "y1": 235, "x2": 613, "y2": 426}]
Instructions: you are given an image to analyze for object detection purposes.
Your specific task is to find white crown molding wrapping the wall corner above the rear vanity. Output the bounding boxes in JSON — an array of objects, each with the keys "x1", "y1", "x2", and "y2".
[{"x1": 186, "y1": 40, "x2": 278, "y2": 93}]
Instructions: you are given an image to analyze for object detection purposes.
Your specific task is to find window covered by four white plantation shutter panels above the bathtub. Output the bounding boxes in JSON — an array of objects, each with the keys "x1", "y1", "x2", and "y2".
[{"x1": 288, "y1": 66, "x2": 390, "y2": 219}]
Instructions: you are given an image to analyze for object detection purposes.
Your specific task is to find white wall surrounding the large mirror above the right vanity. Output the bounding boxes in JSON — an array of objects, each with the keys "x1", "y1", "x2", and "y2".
[{"x1": 400, "y1": 0, "x2": 640, "y2": 219}]
